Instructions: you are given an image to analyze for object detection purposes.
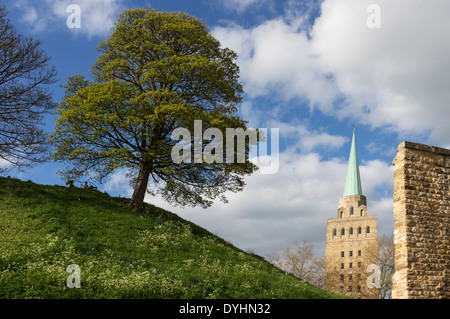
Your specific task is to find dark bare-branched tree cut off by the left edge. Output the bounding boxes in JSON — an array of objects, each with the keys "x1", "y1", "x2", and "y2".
[{"x1": 0, "y1": 6, "x2": 56, "y2": 168}]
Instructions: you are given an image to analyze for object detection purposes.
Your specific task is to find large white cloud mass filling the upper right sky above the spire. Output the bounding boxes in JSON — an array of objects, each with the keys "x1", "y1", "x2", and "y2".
[{"x1": 213, "y1": 0, "x2": 450, "y2": 147}]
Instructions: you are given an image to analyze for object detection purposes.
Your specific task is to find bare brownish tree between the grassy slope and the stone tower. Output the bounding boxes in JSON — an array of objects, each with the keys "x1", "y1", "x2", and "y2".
[{"x1": 266, "y1": 240, "x2": 325, "y2": 288}]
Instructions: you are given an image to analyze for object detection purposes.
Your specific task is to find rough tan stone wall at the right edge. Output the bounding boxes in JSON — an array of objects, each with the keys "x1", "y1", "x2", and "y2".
[{"x1": 392, "y1": 142, "x2": 450, "y2": 299}]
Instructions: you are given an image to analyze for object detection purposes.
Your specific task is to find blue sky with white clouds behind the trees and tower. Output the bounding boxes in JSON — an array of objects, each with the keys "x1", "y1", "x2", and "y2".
[{"x1": 4, "y1": 0, "x2": 450, "y2": 255}]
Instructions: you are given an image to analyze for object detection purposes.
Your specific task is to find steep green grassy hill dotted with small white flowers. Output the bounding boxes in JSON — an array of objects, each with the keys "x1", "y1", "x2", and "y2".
[{"x1": 0, "y1": 178, "x2": 337, "y2": 299}]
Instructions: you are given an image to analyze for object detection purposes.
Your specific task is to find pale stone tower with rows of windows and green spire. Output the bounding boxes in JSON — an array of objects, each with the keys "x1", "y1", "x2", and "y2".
[{"x1": 325, "y1": 129, "x2": 378, "y2": 298}]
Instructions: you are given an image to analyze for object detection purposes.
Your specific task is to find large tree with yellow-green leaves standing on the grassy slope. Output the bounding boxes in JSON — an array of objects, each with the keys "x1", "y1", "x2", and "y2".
[{"x1": 52, "y1": 8, "x2": 256, "y2": 208}]
